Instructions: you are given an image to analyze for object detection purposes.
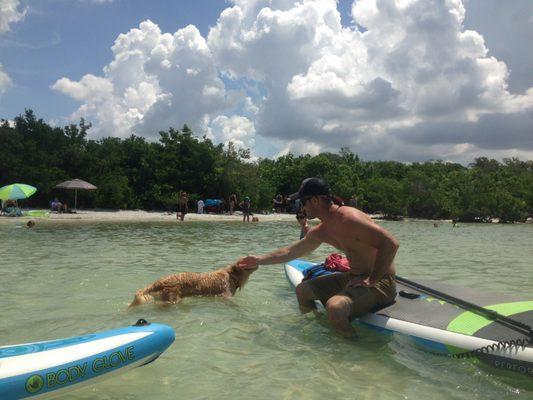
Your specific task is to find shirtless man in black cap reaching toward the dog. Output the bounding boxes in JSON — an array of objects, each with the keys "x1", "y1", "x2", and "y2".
[{"x1": 237, "y1": 178, "x2": 399, "y2": 337}]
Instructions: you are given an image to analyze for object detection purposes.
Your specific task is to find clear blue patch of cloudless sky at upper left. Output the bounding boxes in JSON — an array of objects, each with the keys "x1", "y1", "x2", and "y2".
[{"x1": 0, "y1": 0, "x2": 227, "y2": 119}]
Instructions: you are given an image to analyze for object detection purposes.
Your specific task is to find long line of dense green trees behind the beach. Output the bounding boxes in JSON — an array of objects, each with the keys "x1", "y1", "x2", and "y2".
[{"x1": 0, "y1": 110, "x2": 533, "y2": 222}]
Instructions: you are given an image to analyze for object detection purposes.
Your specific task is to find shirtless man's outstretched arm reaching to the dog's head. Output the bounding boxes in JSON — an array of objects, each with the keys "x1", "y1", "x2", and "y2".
[{"x1": 237, "y1": 229, "x2": 322, "y2": 269}]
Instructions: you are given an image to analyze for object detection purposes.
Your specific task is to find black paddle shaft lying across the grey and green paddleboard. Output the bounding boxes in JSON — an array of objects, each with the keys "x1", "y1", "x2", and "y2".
[{"x1": 396, "y1": 275, "x2": 533, "y2": 340}]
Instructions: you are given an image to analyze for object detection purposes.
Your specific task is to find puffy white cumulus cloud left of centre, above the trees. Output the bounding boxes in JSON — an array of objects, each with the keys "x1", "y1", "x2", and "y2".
[{"x1": 52, "y1": 21, "x2": 239, "y2": 136}]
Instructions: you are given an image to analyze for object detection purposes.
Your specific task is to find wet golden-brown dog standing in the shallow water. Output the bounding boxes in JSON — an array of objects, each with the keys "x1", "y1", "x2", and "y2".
[{"x1": 128, "y1": 264, "x2": 257, "y2": 308}]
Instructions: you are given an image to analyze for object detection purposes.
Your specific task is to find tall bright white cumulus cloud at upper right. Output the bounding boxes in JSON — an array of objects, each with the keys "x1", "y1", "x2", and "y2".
[{"x1": 288, "y1": 0, "x2": 533, "y2": 129}]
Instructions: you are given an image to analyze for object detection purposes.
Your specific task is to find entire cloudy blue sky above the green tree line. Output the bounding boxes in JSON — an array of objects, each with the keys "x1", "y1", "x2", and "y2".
[{"x1": 0, "y1": 0, "x2": 533, "y2": 164}]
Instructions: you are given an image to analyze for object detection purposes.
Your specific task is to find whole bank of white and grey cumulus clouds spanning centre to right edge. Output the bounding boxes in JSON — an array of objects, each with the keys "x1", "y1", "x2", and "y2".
[{"x1": 53, "y1": 0, "x2": 533, "y2": 160}]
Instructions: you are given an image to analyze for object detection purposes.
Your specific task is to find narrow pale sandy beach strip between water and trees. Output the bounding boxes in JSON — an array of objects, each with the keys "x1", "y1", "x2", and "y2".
[{"x1": 0, "y1": 210, "x2": 296, "y2": 224}]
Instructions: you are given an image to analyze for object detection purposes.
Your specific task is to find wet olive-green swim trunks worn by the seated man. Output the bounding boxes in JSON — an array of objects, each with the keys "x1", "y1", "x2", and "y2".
[{"x1": 305, "y1": 272, "x2": 396, "y2": 320}]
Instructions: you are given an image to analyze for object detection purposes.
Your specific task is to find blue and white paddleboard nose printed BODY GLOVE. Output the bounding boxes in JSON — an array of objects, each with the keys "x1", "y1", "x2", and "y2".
[{"x1": 0, "y1": 320, "x2": 174, "y2": 400}]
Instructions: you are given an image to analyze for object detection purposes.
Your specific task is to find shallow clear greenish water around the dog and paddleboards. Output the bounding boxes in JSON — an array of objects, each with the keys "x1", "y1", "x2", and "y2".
[{"x1": 0, "y1": 220, "x2": 533, "y2": 400}]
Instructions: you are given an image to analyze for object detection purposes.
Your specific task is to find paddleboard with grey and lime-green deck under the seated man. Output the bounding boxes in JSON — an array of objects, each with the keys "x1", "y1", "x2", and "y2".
[{"x1": 285, "y1": 260, "x2": 533, "y2": 377}]
